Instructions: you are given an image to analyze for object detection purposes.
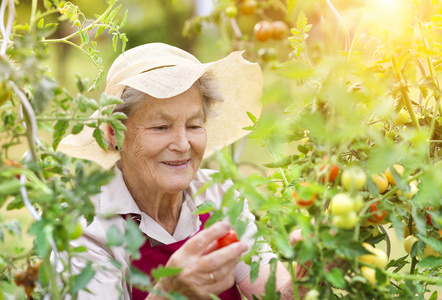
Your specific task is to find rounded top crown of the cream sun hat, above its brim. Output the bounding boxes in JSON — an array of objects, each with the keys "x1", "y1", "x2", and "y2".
[{"x1": 106, "y1": 43, "x2": 201, "y2": 84}]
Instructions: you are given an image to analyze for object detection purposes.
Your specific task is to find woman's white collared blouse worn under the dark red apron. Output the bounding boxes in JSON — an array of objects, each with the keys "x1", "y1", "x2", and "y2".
[{"x1": 63, "y1": 168, "x2": 276, "y2": 300}]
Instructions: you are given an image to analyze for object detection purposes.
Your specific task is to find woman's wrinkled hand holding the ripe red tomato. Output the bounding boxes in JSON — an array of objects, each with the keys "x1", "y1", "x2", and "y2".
[{"x1": 155, "y1": 222, "x2": 248, "y2": 299}]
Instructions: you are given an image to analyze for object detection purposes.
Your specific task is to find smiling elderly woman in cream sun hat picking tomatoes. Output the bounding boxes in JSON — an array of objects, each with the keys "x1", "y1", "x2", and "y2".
[{"x1": 59, "y1": 43, "x2": 308, "y2": 299}]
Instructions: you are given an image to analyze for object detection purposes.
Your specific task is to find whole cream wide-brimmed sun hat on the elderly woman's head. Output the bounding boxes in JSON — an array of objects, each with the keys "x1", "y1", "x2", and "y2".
[{"x1": 58, "y1": 43, "x2": 263, "y2": 169}]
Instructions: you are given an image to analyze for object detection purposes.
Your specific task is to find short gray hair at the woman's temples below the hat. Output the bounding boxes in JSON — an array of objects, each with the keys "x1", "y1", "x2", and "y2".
[{"x1": 114, "y1": 72, "x2": 223, "y2": 123}]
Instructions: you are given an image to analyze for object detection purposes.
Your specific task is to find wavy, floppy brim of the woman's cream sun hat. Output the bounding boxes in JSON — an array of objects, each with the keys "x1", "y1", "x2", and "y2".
[{"x1": 58, "y1": 51, "x2": 263, "y2": 169}]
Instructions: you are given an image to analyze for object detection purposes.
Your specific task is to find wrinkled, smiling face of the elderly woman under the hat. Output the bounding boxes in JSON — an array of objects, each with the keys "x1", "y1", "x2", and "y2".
[{"x1": 121, "y1": 86, "x2": 207, "y2": 193}]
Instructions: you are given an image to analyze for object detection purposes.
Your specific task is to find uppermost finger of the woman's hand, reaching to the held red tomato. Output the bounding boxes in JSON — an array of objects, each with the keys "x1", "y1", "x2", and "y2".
[{"x1": 181, "y1": 221, "x2": 230, "y2": 254}]
